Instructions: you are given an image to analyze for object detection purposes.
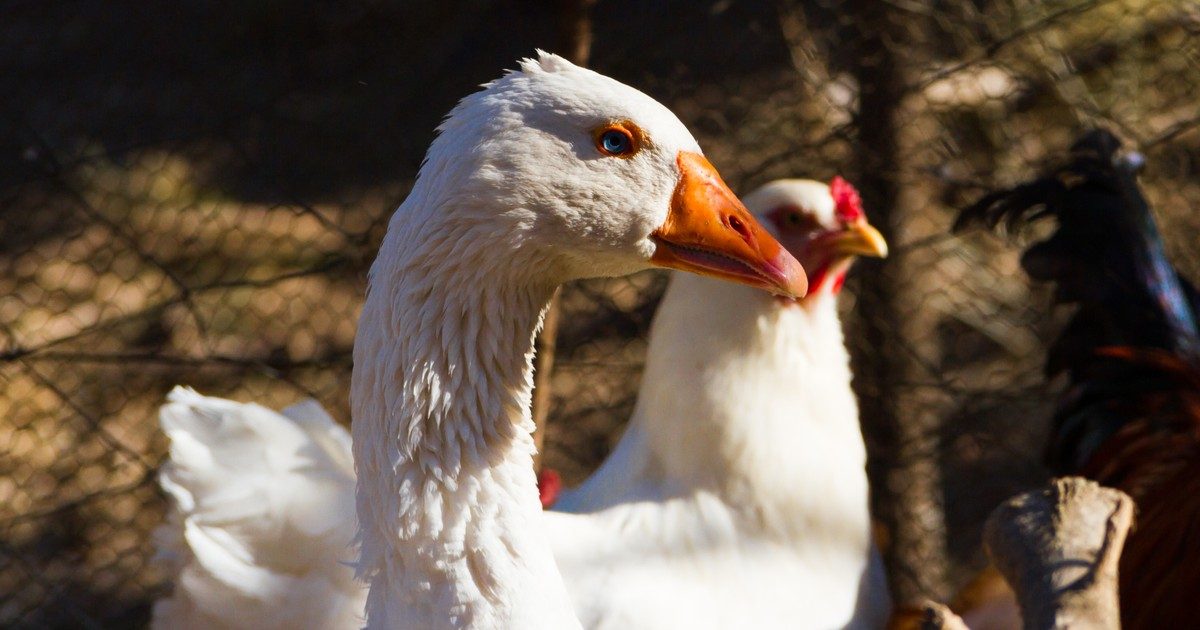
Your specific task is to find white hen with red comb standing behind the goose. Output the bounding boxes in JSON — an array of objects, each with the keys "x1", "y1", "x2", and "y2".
[{"x1": 548, "y1": 179, "x2": 890, "y2": 629}]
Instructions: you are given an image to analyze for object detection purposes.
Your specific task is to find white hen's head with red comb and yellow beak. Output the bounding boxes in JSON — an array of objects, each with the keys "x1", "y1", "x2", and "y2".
[{"x1": 746, "y1": 178, "x2": 888, "y2": 299}]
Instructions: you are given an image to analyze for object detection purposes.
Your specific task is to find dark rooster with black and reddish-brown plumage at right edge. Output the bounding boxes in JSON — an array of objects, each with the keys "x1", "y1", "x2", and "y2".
[{"x1": 955, "y1": 130, "x2": 1200, "y2": 629}]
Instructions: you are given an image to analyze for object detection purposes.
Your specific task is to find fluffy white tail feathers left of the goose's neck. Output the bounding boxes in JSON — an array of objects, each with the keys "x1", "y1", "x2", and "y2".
[{"x1": 154, "y1": 388, "x2": 366, "y2": 629}]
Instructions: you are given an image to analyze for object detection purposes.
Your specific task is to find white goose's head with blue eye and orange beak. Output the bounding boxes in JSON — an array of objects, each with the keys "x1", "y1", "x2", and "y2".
[{"x1": 409, "y1": 52, "x2": 808, "y2": 296}]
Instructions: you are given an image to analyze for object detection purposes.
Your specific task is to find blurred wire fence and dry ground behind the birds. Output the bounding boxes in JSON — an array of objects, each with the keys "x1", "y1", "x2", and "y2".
[{"x1": 0, "y1": 0, "x2": 1200, "y2": 628}]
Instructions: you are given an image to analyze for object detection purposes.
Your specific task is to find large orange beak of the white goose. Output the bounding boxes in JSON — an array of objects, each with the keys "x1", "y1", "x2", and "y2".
[{"x1": 650, "y1": 151, "x2": 809, "y2": 298}]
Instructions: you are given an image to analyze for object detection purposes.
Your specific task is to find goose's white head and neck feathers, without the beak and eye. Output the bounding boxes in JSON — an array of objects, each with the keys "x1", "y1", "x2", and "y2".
[{"x1": 350, "y1": 50, "x2": 715, "y2": 629}]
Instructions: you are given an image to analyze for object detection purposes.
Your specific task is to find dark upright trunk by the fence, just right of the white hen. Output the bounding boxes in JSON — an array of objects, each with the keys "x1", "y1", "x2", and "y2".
[{"x1": 847, "y1": 0, "x2": 947, "y2": 607}]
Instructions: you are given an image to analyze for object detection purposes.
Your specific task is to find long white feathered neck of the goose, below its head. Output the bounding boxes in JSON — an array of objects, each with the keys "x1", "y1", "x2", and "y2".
[{"x1": 350, "y1": 208, "x2": 577, "y2": 628}]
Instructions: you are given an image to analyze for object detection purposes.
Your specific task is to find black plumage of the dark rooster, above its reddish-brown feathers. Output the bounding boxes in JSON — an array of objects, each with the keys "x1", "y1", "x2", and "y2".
[{"x1": 954, "y1": 130, "x2": 1200, "y2": 362}]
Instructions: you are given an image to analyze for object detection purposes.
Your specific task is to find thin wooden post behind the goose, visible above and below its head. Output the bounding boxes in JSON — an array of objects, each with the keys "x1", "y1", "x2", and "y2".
[{"x1": 533, "y1": 0, "x2": 596, "y2": 470}]
